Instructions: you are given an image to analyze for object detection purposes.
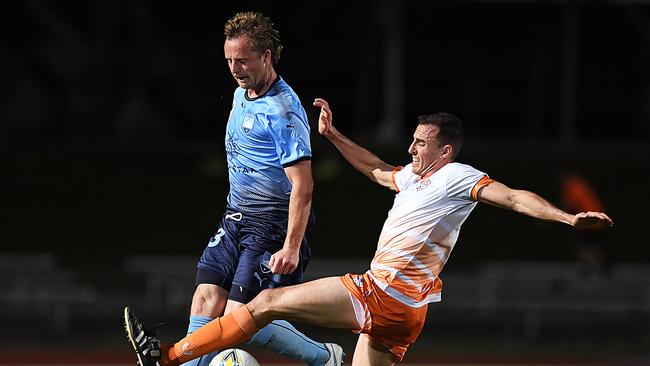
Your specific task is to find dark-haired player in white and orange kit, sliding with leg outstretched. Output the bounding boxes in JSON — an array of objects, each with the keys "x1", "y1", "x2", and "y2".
[{"x1": 125, "y1": 99, "x2": 613, "y2": 366}]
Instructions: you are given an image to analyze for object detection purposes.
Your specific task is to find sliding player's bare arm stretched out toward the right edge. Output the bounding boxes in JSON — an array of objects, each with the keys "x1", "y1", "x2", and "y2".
[{"x1": 478, "y1": 181, "x2": 614, "y2": 229}]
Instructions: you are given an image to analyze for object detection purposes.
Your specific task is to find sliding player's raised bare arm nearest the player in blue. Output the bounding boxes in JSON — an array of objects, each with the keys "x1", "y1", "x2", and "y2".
[{"x1": 314, "y1": 98, "x2": 397, "y2": 190}]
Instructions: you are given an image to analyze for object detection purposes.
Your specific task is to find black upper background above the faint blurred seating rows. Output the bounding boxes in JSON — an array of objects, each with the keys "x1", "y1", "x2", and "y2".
[{"x1": 0, "y1": 0, "x2": 650, "y2": 364}]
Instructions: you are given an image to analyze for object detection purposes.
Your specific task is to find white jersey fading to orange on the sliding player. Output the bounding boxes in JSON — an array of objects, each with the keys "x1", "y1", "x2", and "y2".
[{"x1": 368, "y1": 163, "x2": 492, "y2": 307}]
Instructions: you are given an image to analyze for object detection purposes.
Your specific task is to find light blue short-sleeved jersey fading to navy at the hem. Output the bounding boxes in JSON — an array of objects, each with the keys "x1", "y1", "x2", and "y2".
[{"x1": 226, "y1": 76, "x2": 311, "y2": 220}]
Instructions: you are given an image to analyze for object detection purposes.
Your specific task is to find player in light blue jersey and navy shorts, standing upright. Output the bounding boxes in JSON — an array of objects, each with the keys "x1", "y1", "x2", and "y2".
[{"x1": 175, "y1": 12, "x2": 343, "y2": 365}]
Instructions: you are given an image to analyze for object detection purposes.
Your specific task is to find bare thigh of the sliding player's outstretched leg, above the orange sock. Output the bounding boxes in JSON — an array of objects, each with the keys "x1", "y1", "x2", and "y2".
[{"x1": 249, "y1": 277, "x2": 358, "y2": 329}]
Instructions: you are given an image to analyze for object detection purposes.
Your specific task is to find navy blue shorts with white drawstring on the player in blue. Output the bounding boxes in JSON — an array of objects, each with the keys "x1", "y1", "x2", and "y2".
[{"x1": 196, "y1": 211, "x2": 311, "y2": 303}]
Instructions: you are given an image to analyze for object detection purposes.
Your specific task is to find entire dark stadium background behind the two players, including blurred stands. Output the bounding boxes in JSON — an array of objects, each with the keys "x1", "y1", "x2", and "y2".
[{"x1": 0, "y1": 0, "x2": 650, "y2": 364}]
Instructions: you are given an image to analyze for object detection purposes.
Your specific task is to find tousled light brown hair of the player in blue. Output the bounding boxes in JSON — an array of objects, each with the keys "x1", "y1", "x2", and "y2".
[{"x1": 223, "y1": 11, "x2": 282, "y2": 65}]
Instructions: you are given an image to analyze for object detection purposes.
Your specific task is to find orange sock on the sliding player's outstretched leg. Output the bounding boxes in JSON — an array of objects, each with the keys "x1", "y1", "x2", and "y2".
[{"x1": 160, "y1": 305, "x2": 259, "y2": 366}]
